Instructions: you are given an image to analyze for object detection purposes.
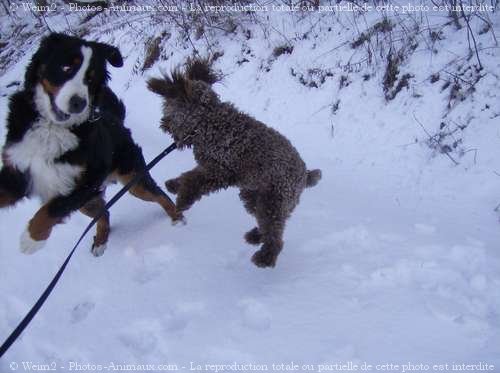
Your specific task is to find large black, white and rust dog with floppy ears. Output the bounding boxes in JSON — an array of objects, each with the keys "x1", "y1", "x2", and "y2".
[{"x1": 0, "y1": 33, "x2": 183, "y2": 256}]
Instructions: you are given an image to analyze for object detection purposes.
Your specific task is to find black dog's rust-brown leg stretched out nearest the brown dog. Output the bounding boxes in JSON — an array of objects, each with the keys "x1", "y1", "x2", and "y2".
[{"x1": 118, "y1": 172, "x2": 184, "y2": 224}]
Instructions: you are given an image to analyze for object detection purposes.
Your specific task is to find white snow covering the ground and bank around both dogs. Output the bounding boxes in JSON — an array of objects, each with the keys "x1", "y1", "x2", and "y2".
[{"x1": 0, "y1": 6, "x2": 500, "y2": 372}]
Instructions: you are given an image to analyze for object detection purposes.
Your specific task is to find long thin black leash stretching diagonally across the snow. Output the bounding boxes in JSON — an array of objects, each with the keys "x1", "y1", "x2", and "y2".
[{"x1": 0, "y1": 143, "x2": 177, "y2": 358}]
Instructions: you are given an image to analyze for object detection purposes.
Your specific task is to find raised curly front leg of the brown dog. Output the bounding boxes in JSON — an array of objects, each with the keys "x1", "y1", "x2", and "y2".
[{"x1": 172, "y1": 166, "x2": 234, "y2": 211}]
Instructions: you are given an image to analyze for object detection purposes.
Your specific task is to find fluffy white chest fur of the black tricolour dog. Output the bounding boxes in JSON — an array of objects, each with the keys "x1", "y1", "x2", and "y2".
[{"x1": 6, "y1": 123, "x2": 82, "y2": 202}]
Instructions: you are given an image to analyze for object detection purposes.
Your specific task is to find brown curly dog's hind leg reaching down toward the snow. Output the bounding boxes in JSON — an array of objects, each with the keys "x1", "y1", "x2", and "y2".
[{"x1": 252, "y1": 193, "x2": 293, "y2": 268}]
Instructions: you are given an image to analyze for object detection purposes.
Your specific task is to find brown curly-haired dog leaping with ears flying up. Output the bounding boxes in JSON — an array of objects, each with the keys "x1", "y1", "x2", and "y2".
[{"x1": 148, "y1": 59, "x2": 321, "y2": 267}]
